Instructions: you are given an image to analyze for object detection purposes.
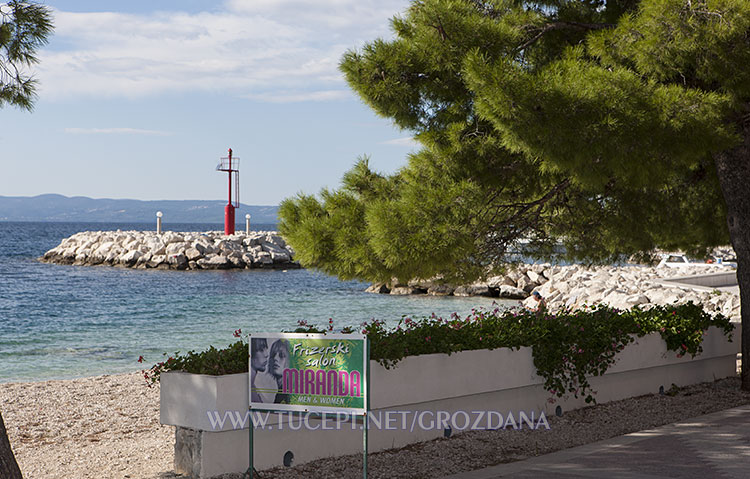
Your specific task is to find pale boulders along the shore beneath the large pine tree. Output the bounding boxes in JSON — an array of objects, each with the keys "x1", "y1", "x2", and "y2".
[{"x1": 368, "y1": 264, "x2": 740, "y2": 318}]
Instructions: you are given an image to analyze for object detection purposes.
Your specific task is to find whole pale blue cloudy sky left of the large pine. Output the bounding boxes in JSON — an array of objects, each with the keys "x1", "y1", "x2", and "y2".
[{"x1": 0, "y1": 0, "x2": 417, "y2": 205}]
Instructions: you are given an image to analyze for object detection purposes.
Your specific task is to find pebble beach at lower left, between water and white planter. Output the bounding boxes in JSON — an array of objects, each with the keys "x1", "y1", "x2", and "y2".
[{"x1": 0, "y1": 373, "x2": 174, "y2": 479}]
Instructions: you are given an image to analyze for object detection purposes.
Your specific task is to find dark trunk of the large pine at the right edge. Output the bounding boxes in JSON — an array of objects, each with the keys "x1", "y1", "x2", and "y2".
[{"x1": 715, "y1": 113, "x2": 750, "y2": 391}]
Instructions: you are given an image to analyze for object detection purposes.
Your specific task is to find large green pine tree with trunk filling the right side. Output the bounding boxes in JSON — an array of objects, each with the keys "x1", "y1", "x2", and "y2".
[{"x1": 281, "y1": 0, "x2": 750, "y2": 390}]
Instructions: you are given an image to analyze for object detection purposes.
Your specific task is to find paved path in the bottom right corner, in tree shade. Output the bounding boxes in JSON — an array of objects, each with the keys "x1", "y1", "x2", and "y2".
[{"x1": 445, "y1": 405, "x2": 750, "y2": 479}]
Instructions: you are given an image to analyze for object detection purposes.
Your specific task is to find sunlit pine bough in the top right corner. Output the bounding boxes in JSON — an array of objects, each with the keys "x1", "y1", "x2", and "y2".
[{"x1": 588, "y1": 0, "x2": 750, "y2": 101}]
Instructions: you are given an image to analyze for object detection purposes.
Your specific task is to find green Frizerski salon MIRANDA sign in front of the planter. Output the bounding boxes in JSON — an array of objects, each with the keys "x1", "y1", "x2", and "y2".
[{"x1": 249, "y1": 333, "x2": 369, "y2": 414}]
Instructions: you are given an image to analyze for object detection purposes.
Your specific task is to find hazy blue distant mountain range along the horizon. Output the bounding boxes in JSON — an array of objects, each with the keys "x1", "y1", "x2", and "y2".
[{"x1": 0, "y1": 194, "x2": 279, "y2": 224}]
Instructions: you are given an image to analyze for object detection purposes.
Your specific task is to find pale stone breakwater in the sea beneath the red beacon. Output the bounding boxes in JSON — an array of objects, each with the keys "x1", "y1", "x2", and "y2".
[{"x1": 40, "y1": 230, "x2": 299, "y2": 270}]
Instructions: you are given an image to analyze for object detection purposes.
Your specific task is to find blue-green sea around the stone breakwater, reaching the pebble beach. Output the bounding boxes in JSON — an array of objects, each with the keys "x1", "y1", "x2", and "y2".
[{"x1": 0, "y1": 221, "x2": 517, "y2": 382}]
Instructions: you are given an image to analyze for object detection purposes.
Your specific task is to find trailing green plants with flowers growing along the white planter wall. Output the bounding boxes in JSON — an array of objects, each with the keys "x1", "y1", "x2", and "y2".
[{"x1": 144, "y1": 303, "x2": 733, "y2": 402}]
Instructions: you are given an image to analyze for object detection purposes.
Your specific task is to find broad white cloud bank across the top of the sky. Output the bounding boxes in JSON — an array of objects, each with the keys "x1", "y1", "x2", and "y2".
[{"x1": 37, "y1": 0, "x2": 408, "y2": 101}]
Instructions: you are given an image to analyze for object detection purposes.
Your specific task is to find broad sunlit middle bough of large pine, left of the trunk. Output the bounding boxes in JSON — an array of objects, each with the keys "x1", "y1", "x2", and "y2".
[{"x1": 466, "y1": 48, "x2": 735, "y2": 191}]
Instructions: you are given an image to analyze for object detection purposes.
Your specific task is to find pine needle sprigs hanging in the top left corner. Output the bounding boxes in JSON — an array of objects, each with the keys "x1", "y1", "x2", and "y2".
[{"x1": 0, "y1": 0, "x2": 52, "y2": 110}]
